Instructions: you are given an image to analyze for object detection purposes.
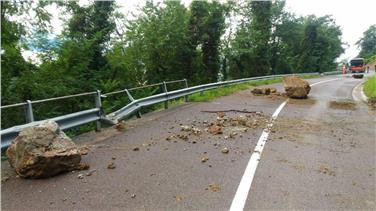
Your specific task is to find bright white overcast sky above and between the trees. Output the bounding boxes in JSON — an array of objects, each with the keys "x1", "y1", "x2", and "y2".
[{"x1": 23, "y1": 0, "x2": 376, "y2": 61}]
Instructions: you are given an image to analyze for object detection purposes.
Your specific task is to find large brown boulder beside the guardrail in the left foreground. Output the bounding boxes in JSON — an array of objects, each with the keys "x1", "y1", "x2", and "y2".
[{"x1": 6, "y1": 121, "x2": 81, "y2": 178}]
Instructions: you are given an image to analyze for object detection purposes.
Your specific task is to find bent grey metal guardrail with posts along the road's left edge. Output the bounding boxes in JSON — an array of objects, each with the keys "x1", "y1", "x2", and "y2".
[{"x1": 0, "y1": 71, "x2": 337, "y2": 149}]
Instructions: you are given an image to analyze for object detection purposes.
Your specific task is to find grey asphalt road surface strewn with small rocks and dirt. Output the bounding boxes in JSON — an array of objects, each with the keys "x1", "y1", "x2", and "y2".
[{"x1": 1, "y1": 76, "x2": 376, "y2": 210}]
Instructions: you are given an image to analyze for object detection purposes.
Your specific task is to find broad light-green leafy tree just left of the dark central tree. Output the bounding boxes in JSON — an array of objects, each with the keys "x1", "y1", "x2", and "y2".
[{"x1": 125, "y1": 1, "x2": 187, "y2": 83}]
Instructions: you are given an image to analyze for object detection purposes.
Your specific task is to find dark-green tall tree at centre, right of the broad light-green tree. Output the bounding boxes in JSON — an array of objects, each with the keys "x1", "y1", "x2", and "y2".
[{"x1": 184, "y1": 1, "x2": 227, "y2": 83}]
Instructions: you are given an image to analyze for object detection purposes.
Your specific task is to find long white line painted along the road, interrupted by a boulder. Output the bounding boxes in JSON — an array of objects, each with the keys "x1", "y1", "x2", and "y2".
[{"x1": 230, "y1": 78, "x2": 341, "y2": 211}]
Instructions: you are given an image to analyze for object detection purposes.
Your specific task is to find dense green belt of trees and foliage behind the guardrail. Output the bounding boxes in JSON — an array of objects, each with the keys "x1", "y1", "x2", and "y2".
[{"x1": 1, "y1": 1, "x2": 348, "y2": 128}]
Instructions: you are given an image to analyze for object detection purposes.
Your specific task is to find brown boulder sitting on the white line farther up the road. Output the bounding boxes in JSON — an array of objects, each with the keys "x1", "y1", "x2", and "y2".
[{"x1": 283, "y1": 76, "x2": 311, "y2": 99}]
